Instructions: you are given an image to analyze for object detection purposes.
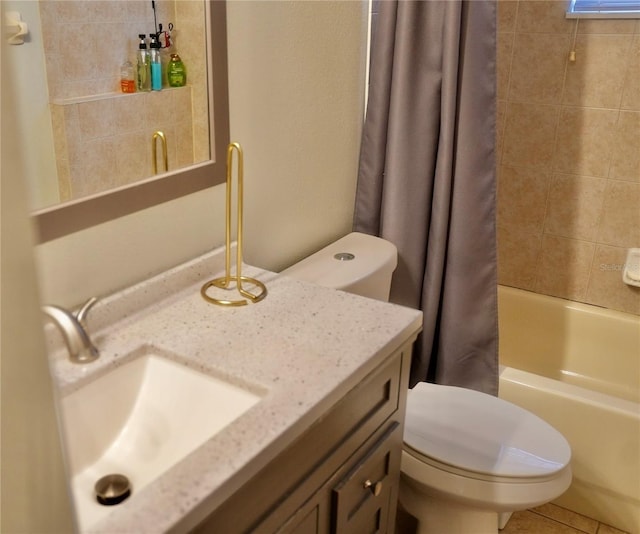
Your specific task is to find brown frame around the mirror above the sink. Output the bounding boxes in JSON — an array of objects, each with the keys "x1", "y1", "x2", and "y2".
[{"x1": 32, "y1": 0, "x2": 230, "y2": 244}]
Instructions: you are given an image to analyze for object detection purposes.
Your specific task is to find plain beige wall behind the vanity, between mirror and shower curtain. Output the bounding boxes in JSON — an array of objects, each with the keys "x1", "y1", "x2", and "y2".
[{"x1": 36, "y1": 1, "x2": 366, "y2": 306}]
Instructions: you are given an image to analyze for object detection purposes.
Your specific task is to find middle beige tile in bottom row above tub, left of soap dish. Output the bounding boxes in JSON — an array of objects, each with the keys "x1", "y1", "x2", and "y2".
[{"x1": 535, "y1": 234, "x2": 595, "y2": 301}]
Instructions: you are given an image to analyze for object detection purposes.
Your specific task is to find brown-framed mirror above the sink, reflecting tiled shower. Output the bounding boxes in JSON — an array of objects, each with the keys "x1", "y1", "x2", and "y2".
[{"x1": 9, "y1": 0, "x2": 229, "y2": 243}]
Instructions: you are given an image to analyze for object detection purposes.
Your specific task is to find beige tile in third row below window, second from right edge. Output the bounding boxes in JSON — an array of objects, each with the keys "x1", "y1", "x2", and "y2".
[{"x1": 554, "y1": 107, "x2": 618, "y2": 177}]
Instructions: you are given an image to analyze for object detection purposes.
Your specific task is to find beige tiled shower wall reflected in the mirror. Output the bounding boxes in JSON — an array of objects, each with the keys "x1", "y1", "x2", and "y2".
[{"x1": 39, "y1": 0, "x2": 209, "y2": 201}]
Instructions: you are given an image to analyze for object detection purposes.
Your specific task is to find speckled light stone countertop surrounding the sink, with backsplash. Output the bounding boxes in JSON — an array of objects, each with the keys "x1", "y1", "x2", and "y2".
[{"x1": 47, "y1": 249, "x2": 422, "y2": 534}]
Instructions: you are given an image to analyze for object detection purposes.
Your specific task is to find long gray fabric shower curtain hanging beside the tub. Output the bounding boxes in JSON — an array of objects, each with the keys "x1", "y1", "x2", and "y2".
[{"x1": 354, "y1": 0, "x2": 498, "y2": 395}]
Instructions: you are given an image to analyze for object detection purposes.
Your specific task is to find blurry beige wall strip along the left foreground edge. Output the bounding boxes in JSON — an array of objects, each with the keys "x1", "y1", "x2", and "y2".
[{"x1": 0, "y1": 13, "x2": 74, "y2": 534}]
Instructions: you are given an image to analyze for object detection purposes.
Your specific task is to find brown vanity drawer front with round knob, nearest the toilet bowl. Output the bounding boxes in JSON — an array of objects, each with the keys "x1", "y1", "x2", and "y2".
[{"x1": 332, "y1": 421, "x2": 402, "y2": 534}]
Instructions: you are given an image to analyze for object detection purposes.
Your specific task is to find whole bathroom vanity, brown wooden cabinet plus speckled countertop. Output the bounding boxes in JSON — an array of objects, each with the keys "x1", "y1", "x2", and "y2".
[{"x1": 48, "y1": 249, "x2": 422, "y2": 534}]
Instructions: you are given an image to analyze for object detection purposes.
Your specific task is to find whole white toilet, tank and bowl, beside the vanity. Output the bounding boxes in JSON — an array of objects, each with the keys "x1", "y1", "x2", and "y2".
[{"x1": 281, "y1": 233, "x2": 571, "y2": 534}]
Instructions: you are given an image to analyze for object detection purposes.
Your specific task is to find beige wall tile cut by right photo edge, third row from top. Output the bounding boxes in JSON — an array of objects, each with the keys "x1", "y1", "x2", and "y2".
[{"x1": 609, "y1": 111, "x2": 640, "y2": 182}]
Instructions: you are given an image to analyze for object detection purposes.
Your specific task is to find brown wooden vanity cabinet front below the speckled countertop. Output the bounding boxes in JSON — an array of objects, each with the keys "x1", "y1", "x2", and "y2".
[{"x1": 194, "y1": 342, "x2": 412, "y2": 534}]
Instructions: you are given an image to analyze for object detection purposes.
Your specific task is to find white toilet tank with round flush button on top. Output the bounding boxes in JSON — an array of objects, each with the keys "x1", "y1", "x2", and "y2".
[{"x1": 280, "y1": 232, "x2": 398, "y2": 301}]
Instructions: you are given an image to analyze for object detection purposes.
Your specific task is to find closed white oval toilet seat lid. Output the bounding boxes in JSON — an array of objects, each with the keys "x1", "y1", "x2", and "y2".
[{"x1": 404, "y1": 382, "x2": 571, "y2": 478}]
